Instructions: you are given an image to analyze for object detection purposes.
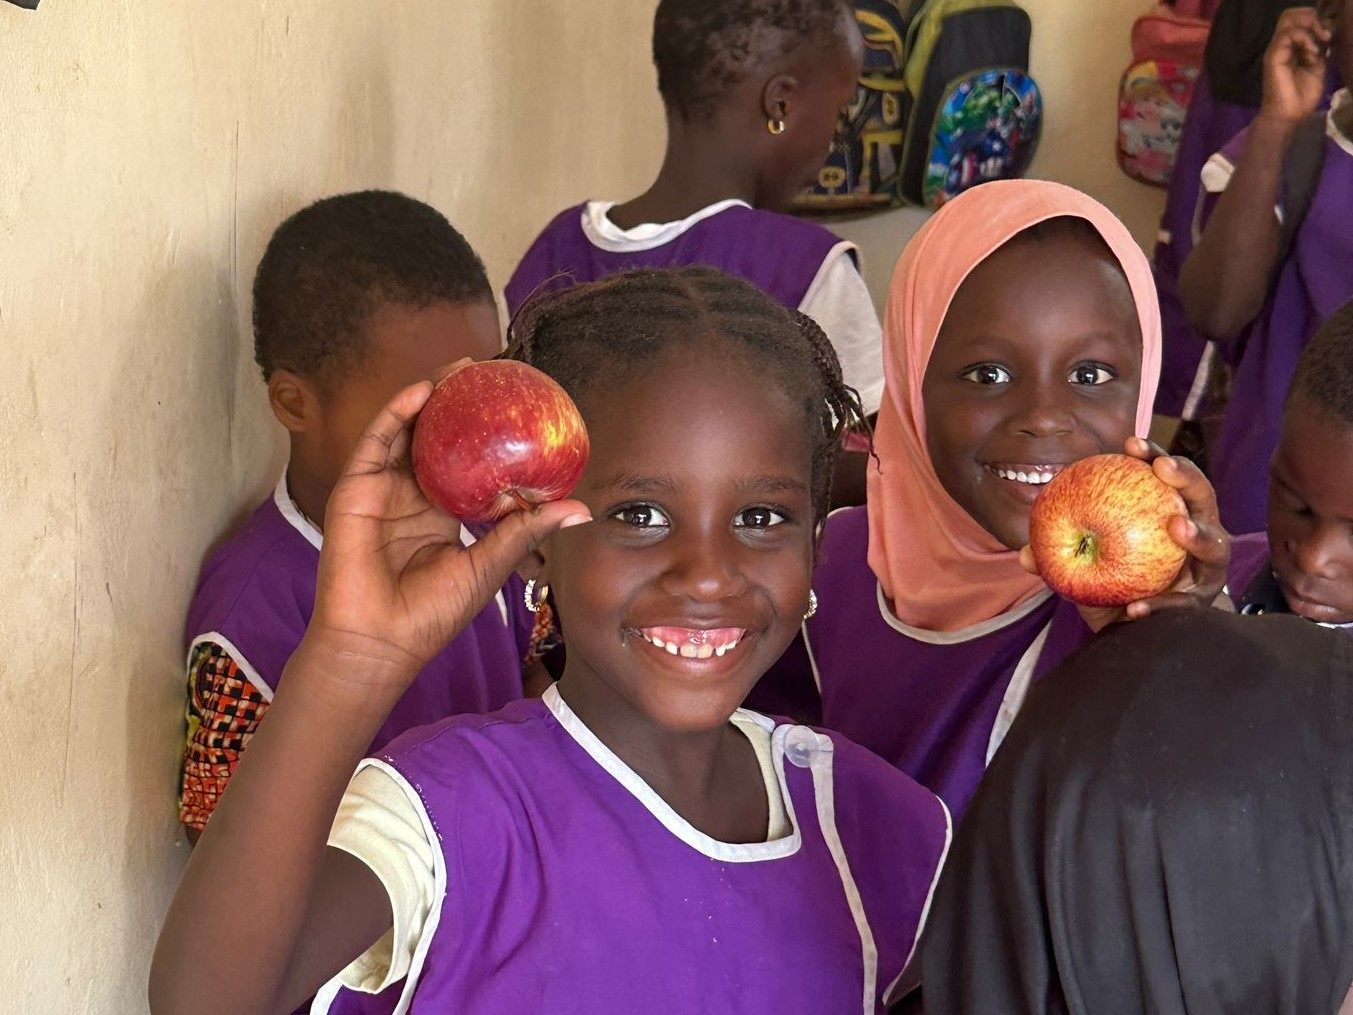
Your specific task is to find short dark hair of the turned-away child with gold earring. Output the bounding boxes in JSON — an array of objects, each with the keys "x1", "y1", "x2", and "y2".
[{"x1": 653, "y1": 0, "x2": 851, "y2": 120}]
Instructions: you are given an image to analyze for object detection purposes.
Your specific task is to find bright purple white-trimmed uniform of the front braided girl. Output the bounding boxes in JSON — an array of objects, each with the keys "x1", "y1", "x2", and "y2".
[{"x1": 315, "y1": 687, "x2": 950, "y2": 1015}]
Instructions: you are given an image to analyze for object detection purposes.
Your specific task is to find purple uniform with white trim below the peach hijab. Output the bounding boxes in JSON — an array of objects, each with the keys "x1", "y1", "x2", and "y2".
[{"x1": 763, "y1": 508, "x2": 1091, "y2": 817}]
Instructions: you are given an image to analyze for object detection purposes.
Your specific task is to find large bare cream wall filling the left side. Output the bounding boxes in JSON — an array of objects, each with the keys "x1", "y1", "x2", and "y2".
[{"x1": 0, "y1": 0, "x2": 663, "y2": 1012}]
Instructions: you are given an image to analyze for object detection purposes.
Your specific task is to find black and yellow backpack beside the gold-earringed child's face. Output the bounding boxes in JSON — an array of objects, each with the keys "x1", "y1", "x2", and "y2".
[{"x1": 794, "y1": 0, "x2": 920, "y2": 212}]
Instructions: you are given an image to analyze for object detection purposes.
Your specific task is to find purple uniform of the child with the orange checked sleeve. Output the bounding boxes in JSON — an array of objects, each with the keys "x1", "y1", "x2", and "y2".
[{"x1": 187, "y1": 478, "x2": 530, "y2": 750}]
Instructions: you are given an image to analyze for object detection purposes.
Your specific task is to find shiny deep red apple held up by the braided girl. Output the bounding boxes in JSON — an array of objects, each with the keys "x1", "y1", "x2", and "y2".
[{"x1": 413, "y1": 360, "x2": 589, "y2": 522}]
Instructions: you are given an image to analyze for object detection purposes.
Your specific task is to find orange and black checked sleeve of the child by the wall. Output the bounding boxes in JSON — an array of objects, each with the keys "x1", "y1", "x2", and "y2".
[{"x1": 179, "y1": 641, "x2": 268, "y2": 832}]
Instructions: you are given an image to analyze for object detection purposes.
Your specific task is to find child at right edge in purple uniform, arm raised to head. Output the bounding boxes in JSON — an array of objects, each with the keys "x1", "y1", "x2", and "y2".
[{"x1": 1180, "y1": 0, "x2": 1353, "y2": 532}]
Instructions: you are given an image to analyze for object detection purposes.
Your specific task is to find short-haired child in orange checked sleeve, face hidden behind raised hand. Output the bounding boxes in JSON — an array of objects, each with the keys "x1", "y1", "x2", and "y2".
[{"x1": 180, "y1": 191, "x2": 530, "y2": 838}]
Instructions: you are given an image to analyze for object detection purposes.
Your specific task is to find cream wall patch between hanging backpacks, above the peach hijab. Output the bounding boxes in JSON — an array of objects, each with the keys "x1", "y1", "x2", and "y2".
[{"x1": 829, "y1": 0, "x2": 1165, "y2": 310}]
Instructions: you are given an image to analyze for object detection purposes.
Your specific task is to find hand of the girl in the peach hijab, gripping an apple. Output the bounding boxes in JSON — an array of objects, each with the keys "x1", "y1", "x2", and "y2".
[{"x1": 1020, "y1": 437, "x2": 1231, "y2": 631}]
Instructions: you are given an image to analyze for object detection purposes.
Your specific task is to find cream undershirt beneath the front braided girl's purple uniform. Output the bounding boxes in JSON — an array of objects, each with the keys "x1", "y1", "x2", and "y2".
[{"x1": 329, "y1": 712, "x2": 790, "y2": 993}]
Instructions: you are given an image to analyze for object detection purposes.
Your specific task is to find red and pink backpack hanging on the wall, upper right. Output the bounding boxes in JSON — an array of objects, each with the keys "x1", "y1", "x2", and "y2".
[{"x1": 1118, "y1": 4, "x2": 1210, "y2": 187}]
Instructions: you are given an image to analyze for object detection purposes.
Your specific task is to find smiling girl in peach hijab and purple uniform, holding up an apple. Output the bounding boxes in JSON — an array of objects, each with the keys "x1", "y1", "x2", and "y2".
[{"x1": 762, "y1": 180, "x2": 1227, "y2": 813}]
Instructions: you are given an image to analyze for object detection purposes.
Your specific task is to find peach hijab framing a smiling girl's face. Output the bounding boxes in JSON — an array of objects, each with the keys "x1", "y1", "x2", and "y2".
[{"x1": 869, "y1": 180, "x2": 1161, "y2": 631}]
